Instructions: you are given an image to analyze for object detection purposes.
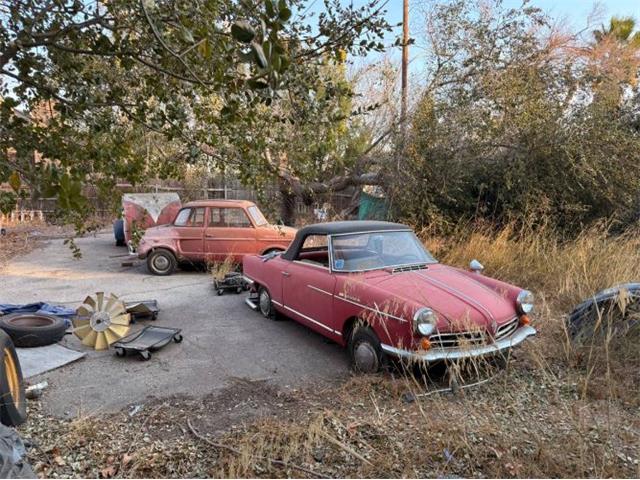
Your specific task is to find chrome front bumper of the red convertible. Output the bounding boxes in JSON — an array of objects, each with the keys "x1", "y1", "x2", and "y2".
[{"x1": 381, "y1": 325, "x2": 537, "y2": 362}]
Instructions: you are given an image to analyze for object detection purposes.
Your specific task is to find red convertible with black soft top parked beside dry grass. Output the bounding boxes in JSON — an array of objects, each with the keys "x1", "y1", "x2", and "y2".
[{"x1": 243, "y1": 221, "x2": 536, "y2": 372}]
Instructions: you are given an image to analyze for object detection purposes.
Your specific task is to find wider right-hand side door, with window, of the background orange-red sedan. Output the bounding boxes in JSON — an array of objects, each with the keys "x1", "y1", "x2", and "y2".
[{"x1": 204, "y1": 207, "x2": 259, "y2": 262}]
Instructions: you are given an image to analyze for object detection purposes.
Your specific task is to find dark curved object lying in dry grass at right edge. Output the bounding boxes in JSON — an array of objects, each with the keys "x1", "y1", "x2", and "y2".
[{"x1": 567, "y1": 283, "x2": 640, "y2": 344}]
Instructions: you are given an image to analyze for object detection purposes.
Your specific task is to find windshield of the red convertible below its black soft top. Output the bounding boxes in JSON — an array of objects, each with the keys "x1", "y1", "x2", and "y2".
[{"x1": 331, "y1": 230, "x2": 437, "y2": 272}]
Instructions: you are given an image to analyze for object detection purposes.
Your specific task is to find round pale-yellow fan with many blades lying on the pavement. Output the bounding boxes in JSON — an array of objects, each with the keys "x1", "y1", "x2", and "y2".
[{"x1": 73, "y1": 292, "x2": 131, "y2": 350}]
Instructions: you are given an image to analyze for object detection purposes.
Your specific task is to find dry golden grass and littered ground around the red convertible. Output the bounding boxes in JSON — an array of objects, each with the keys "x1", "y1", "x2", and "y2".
[{"x1": 20, "y1": 223, "x2": 640, "y2": 477}]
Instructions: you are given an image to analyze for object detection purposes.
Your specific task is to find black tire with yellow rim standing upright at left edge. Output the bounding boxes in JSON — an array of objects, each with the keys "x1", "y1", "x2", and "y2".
[{"x1": 0, "y1": 332, "x2": 27, "y2": 427}]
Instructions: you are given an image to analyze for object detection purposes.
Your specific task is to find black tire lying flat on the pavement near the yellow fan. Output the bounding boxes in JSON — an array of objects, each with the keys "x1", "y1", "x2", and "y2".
[{"x1": 0, "y1": 313, "x2": 67, "y2": 347}]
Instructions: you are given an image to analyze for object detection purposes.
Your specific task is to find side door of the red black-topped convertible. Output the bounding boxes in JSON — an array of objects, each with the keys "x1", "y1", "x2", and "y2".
[{"x1": 282, "y1": 235, "x2": 339, "y2": 336}]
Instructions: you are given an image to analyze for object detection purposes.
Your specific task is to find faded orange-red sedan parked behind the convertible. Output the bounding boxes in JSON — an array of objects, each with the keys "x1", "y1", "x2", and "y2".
[{"x1": 137, "y1": 200, "x2": 296, "y2": 275}]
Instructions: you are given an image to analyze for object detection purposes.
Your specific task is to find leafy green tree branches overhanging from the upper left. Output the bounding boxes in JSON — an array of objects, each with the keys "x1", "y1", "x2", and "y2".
[{"x1": 0, "y1": 0, "x2": 388, "y2": 223}]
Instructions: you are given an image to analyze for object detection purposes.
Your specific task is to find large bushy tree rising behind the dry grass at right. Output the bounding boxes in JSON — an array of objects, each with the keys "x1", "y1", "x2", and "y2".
[{"x1": 392, "y1": 2, "x2": 640, "y2": 232}]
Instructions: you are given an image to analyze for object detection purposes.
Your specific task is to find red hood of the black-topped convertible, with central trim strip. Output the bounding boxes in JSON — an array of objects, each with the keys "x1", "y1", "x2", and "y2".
[{"x1": 366, "y1": 264, "x2": 517, "y2": 330}]
